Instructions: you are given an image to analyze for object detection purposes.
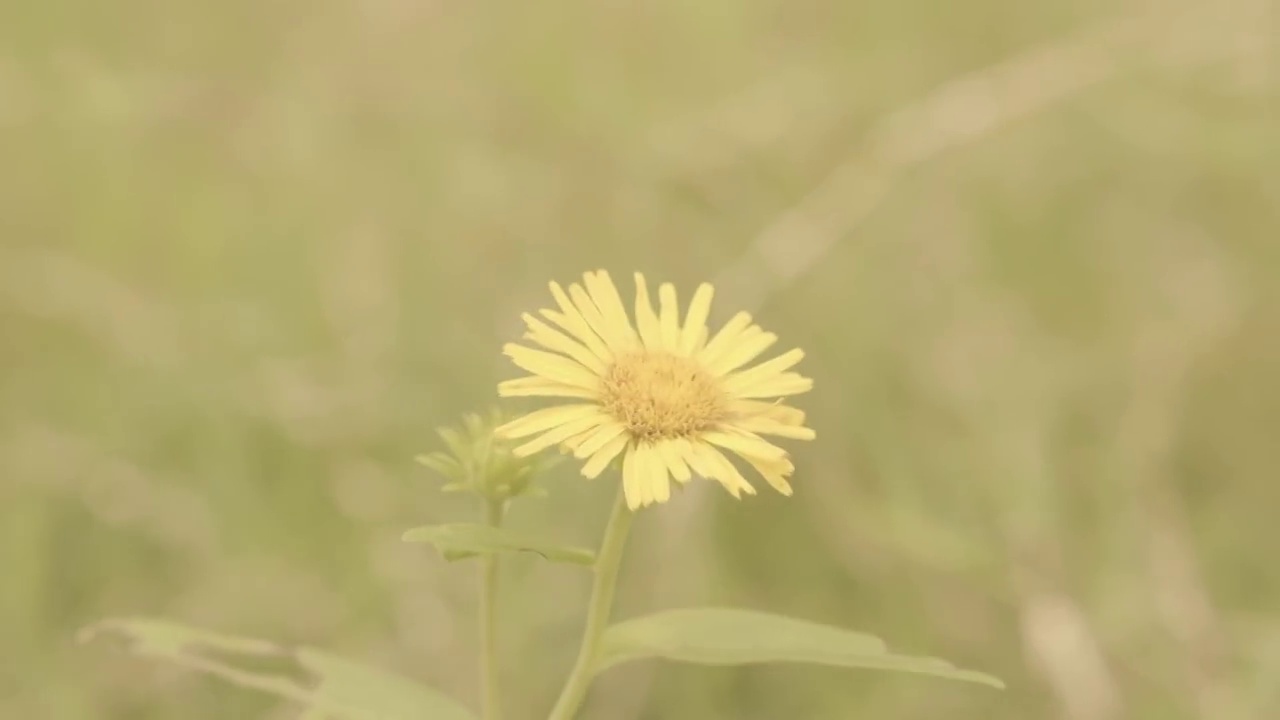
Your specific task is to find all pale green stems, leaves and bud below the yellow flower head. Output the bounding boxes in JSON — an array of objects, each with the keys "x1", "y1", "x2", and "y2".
[{"x1": 90, "y1": 415, "x2": 1004, "y2": 720}]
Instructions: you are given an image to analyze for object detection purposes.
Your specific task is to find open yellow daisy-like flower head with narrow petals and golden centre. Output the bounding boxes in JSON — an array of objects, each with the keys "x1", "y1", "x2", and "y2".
[{"x1": 495, "y1": 270, "x2": 814, "y2": 510}]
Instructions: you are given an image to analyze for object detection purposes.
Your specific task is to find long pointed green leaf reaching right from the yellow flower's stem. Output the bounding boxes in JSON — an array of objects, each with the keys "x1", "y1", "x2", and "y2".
[{"x1": 596, "y1": 607, "x2": 1005, "y2": 688}]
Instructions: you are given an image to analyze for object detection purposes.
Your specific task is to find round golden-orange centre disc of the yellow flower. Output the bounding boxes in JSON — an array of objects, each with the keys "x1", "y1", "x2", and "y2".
[{"x1": 600, "y1": 352, "x2": 726, "y2": 442}]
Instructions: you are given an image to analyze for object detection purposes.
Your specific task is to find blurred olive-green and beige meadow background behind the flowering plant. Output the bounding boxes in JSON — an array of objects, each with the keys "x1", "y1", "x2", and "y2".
[{"x1": 0, "y1": 0, "x2": 1280, "y2": 720}]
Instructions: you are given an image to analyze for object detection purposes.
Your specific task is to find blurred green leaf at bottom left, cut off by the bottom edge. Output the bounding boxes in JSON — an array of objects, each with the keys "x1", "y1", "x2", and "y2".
[{"x1": 81, "y1": 618, "x2": 475, "y2": 720}]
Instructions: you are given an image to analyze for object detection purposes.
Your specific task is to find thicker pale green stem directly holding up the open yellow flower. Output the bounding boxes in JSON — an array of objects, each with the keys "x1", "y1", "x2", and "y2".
[{"x1": 549, "y1": 483, "x2": 632, "y2": 720}]
